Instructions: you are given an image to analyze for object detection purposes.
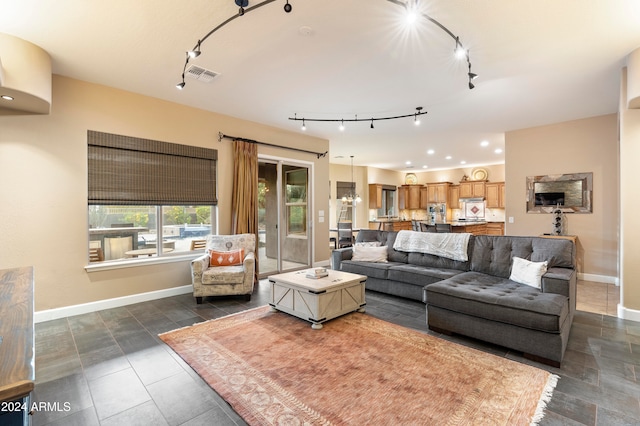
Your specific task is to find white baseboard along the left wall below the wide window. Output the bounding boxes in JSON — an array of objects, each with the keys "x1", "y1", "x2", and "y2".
[{"x1": 33, "y1": 284, "x2": 193, "y2": 324}]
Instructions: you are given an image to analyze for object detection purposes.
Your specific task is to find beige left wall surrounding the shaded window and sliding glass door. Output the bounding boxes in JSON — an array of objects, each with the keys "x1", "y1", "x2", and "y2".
[{"x1": 0, "y1": 76, "x2": 329, "y2": 311}]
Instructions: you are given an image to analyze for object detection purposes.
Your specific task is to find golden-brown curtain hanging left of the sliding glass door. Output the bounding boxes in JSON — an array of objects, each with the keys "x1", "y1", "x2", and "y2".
[{"x1": 231, "y1": 140, "x2": 258, "y2": 281}]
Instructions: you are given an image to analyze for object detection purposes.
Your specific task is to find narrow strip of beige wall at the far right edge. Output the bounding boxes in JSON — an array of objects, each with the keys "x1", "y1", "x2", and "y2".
[{"x1": 618, "y1": 65, "x2": 640, "y2": 312}]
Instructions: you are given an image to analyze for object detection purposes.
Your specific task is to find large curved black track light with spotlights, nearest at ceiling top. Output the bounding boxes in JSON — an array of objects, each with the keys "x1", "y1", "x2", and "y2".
[{"x1": 176, "y1": 0, "x2": 478, "y2": 90}]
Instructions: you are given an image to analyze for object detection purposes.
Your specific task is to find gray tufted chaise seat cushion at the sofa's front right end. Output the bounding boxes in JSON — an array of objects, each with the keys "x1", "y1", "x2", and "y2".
[{"x1": 424, "y1": 272, "x2": 569, "y2": 333}]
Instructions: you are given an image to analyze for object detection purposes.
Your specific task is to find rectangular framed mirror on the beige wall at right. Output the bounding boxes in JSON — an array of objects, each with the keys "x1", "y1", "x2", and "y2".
[{"x1": 527, "y1": 173, "x2": 593, "y2": 213}]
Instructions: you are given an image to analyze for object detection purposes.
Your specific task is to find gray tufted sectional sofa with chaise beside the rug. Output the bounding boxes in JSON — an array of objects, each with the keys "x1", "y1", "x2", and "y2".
[{"x1": 331, "y1": 230, "x2": 577, "y2": 366}]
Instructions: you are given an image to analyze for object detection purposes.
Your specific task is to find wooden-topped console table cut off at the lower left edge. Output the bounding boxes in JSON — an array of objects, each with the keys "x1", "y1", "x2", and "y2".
[{"x1": 0, "y1": 267, "x2": 36, "y2": 424}]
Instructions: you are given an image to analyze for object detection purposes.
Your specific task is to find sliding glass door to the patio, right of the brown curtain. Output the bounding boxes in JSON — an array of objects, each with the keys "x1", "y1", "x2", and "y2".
[{"x1": 257, "y1": 159, "x2": 312, "y2": 278}]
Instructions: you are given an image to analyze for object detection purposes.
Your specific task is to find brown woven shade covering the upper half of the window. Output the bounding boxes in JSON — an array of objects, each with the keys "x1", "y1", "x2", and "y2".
[{"x1": 87, "y1": 130, "x2": 218, "y2": 205}]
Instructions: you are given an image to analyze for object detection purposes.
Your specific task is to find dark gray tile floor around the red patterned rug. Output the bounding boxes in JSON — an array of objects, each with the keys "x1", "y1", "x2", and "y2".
[{"x1": 33, "y1": 281, "x2": 640, "y2": 426}]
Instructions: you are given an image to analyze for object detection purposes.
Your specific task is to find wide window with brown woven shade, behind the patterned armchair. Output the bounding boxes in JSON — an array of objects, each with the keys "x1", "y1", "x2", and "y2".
[{"x1": 88, "y1": 131, "x2": 217, "y2": 261}]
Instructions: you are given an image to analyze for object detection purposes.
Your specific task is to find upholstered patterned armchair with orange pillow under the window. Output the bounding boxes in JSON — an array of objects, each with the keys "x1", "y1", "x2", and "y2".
[{"x1": 191, "y1": 234, "x2": 256, "y2": 303}]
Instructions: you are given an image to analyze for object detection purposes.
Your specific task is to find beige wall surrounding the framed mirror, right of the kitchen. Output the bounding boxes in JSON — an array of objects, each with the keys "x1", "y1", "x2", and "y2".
[{"x1": 505, "y1": 114, "x2": 619, "y2": 282}]
